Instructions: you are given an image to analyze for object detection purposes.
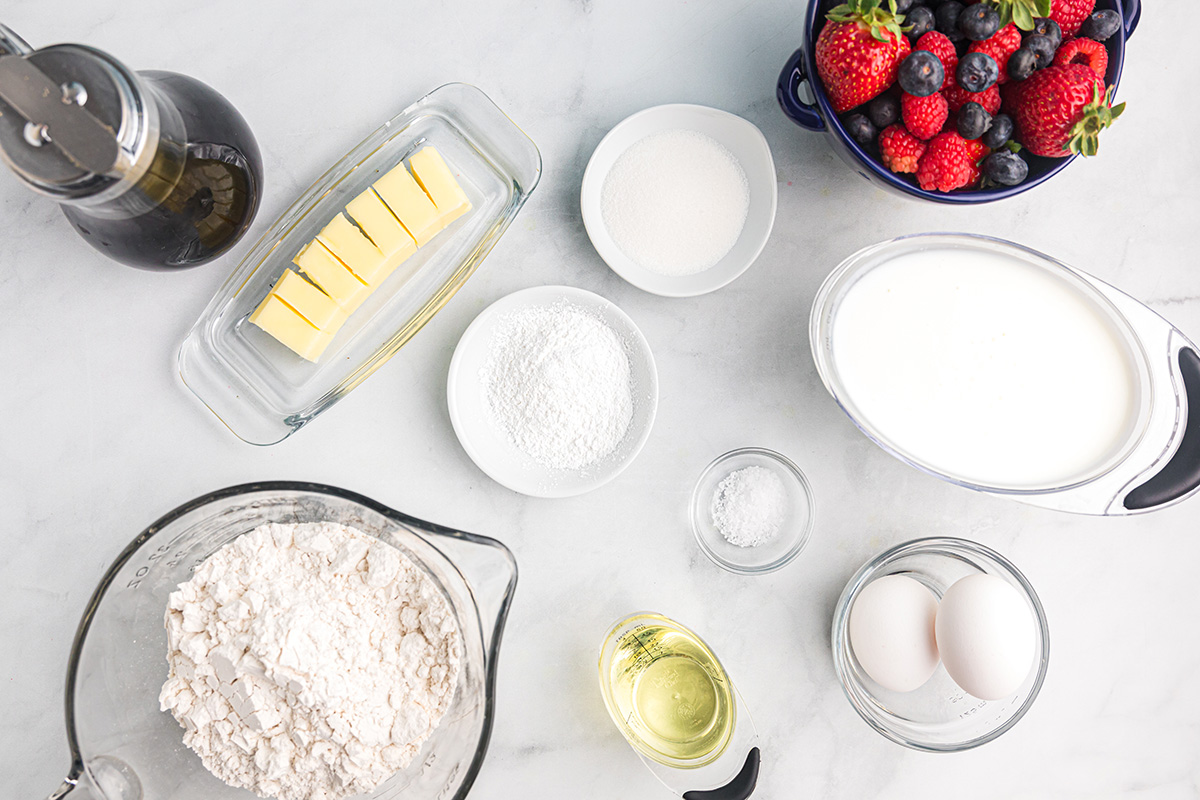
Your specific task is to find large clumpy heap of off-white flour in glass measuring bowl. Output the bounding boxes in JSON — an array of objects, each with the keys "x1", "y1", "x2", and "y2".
[{"x1": 160, "y1": 523, "x2": 461, "y2": 800}]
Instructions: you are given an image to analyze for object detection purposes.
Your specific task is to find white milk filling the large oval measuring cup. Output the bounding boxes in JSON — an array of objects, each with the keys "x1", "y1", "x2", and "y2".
[{"x1": 830, "y1": 248, "x2": 1139, "y2": 488}]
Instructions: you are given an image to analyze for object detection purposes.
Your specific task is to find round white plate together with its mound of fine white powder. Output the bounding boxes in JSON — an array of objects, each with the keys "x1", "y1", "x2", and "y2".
[{"x1": 446, "y1": 287, "x2": 659, "y2": 498}]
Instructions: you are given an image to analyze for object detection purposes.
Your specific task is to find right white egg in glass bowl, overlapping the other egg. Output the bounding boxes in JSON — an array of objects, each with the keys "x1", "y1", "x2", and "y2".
[{"x1": 935, "y1": 573, "x2": 1038, "y2": 700}]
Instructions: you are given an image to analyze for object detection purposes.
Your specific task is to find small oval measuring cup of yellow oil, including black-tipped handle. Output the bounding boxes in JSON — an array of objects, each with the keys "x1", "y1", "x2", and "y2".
[{"x1": 600, "y1": 612, "x2": 760, "y2": 800}]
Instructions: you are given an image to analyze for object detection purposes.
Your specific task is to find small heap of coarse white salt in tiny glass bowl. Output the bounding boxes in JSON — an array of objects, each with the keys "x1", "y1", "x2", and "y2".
[{"x1": 712, "y1": 467, "x2": 788, "y2": 547}]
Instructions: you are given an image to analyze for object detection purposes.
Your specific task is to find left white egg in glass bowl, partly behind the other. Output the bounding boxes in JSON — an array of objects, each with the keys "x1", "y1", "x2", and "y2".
[{"x1": 850, "y1": 575, "x2": 937, "y2": 692}]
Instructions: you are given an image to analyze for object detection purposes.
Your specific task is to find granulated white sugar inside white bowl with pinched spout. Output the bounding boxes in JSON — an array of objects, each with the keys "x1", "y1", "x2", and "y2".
[{"x1": 601, "y1": 131, "x2": 750, "y2": 277}]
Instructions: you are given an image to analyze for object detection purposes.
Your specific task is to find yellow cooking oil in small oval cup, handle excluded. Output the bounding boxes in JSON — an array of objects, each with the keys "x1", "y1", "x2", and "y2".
[{"x1": 601, "y1": 614, "x2": 737, "y2": 766}]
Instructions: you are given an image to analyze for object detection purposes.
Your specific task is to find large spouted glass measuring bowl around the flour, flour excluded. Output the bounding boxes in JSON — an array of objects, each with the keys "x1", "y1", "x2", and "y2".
[{"x1": 41, "y1": 481, "x2": 517, "y2": 800}]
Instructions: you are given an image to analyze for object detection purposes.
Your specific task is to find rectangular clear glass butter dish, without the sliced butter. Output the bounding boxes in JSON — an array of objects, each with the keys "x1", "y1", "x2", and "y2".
[{"x1": 179, "y1": 84, "x2": 541, "y2": 445}]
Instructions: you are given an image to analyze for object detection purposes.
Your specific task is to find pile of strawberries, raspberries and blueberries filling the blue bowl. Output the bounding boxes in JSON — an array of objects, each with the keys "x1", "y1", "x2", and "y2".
[{"x1": 815, "y1": 0, "x2": 1124, "y2": 192}]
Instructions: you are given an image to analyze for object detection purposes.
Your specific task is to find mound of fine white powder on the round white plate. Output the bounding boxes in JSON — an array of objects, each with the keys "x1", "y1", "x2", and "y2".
[{"x1": 480, "y1": 302, "x2": 634, "y2": 469}]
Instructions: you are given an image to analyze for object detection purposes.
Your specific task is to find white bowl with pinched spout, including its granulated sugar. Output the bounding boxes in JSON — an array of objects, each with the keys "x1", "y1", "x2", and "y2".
[{"x1": 580, "y1": 104, "x2": 778, "y2": 297}]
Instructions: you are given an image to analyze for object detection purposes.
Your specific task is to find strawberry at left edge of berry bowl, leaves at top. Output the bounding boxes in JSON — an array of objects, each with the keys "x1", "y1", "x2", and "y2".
[{"x1": 816, "y1": 0, "x2": 912, "y2": 114}]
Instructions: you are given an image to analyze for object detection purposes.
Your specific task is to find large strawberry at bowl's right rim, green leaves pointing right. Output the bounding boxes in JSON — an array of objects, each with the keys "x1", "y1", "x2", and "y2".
[{"x1": 1008, "y1": 64, "x2": 1124, "y2": 157}]
